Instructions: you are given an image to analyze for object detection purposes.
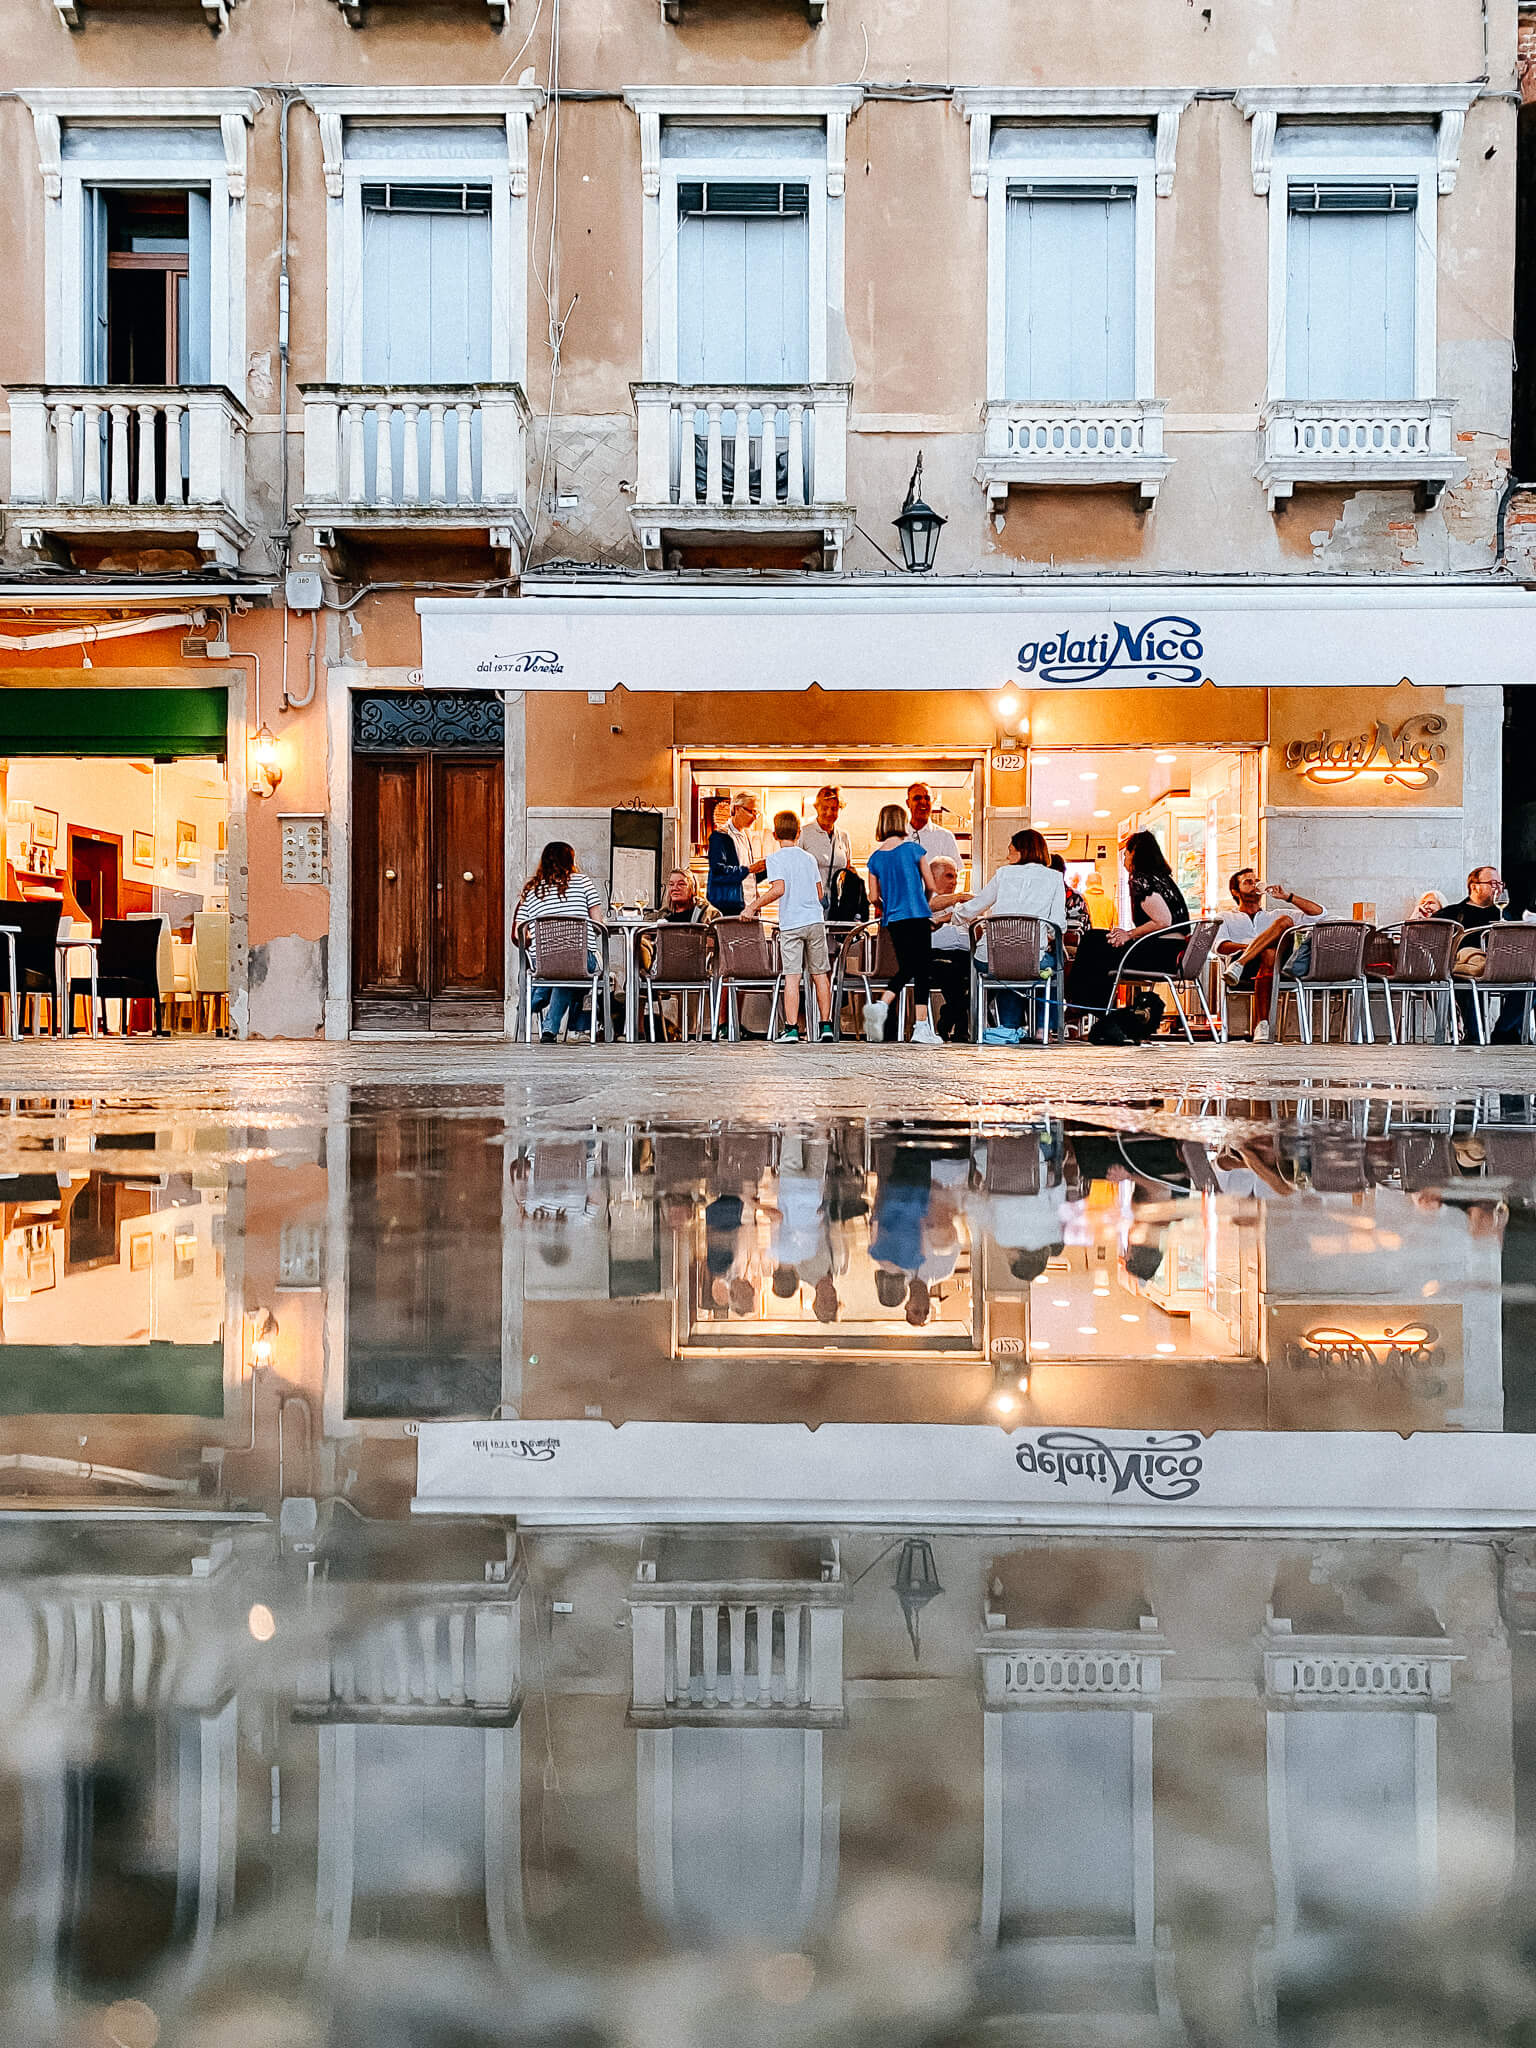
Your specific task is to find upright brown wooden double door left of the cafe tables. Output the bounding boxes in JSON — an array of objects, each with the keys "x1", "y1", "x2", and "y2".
[{"x1": 352, "y1": 754, "x2": 506, "y2": 1030}]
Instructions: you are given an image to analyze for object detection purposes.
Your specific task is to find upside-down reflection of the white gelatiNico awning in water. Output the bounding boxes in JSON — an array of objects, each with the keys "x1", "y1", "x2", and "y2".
[{"x1": 412, "y1": 1421, "x2": 1536, "y2": 1530}]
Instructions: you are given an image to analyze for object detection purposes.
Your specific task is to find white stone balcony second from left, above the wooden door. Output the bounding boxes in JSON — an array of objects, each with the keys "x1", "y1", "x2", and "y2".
[{"x1": 299, "y1": 383, "x2": 528, "y2": 573}]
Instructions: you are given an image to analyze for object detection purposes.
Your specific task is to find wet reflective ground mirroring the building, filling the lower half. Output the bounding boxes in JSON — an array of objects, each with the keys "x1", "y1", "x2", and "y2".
[{"x1": 0, "y1": 1047, "x2": 1536, "y2": 2048}]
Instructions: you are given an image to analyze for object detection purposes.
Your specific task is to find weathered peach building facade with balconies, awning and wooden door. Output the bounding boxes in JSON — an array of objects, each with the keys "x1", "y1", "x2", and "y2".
[{"x1": 0, "y1": 0, "x2": 1530, "y2": 1036}]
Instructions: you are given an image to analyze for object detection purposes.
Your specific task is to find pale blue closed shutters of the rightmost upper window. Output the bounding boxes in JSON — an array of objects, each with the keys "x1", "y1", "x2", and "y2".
[{"x1": 1286, "y1": 178, "x2": 1419, "y2": 399}]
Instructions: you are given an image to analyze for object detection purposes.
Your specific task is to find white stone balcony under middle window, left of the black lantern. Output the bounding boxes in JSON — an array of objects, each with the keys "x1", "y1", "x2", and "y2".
[{"x1": 631, "y1": 383, "x2": 854, "y2": 569}]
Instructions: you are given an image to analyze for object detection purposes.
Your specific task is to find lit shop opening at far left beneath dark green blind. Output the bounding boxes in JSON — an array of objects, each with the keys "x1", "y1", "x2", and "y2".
[{"x1": 0, "y1": 690, "x2": 229, "y2": 1032}]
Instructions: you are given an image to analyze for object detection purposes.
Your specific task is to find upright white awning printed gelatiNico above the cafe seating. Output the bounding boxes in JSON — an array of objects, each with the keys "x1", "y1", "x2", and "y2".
[{"x1": 416, "y1": 584, "x2": 1536, "y2": 690}]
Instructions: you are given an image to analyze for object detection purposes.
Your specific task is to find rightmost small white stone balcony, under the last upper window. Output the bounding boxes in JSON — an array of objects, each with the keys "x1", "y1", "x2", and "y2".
[{"x1": 1253, "y1": 397, "x2": 1466, "y2": 512}]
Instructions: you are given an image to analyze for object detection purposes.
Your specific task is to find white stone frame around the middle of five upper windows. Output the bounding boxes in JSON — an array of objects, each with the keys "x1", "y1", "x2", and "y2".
[{"x1": 625, "y1": 86, "x2": 864, "y2": 383}]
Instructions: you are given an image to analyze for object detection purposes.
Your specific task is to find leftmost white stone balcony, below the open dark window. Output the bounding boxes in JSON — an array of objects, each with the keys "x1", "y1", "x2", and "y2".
[{"x1": 10, "y1": 385, "x2": 250, "y2": 567}]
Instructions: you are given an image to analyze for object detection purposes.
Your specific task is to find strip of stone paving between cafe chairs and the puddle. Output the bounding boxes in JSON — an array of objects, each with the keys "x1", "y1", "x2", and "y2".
[{"x1": 0, "y1": 1038, "x2": 1536, "y2": 1135}]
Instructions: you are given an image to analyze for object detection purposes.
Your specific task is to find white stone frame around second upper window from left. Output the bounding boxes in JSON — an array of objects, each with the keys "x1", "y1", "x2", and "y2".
[{"x1": 303, "y1": 86, "x2": 545, "y2": 387}]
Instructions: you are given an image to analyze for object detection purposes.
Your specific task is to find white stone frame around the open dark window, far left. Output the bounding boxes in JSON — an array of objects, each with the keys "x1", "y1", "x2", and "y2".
[{"x1": 23, "y1": 86, "x2": 262, "y2": 403}]
